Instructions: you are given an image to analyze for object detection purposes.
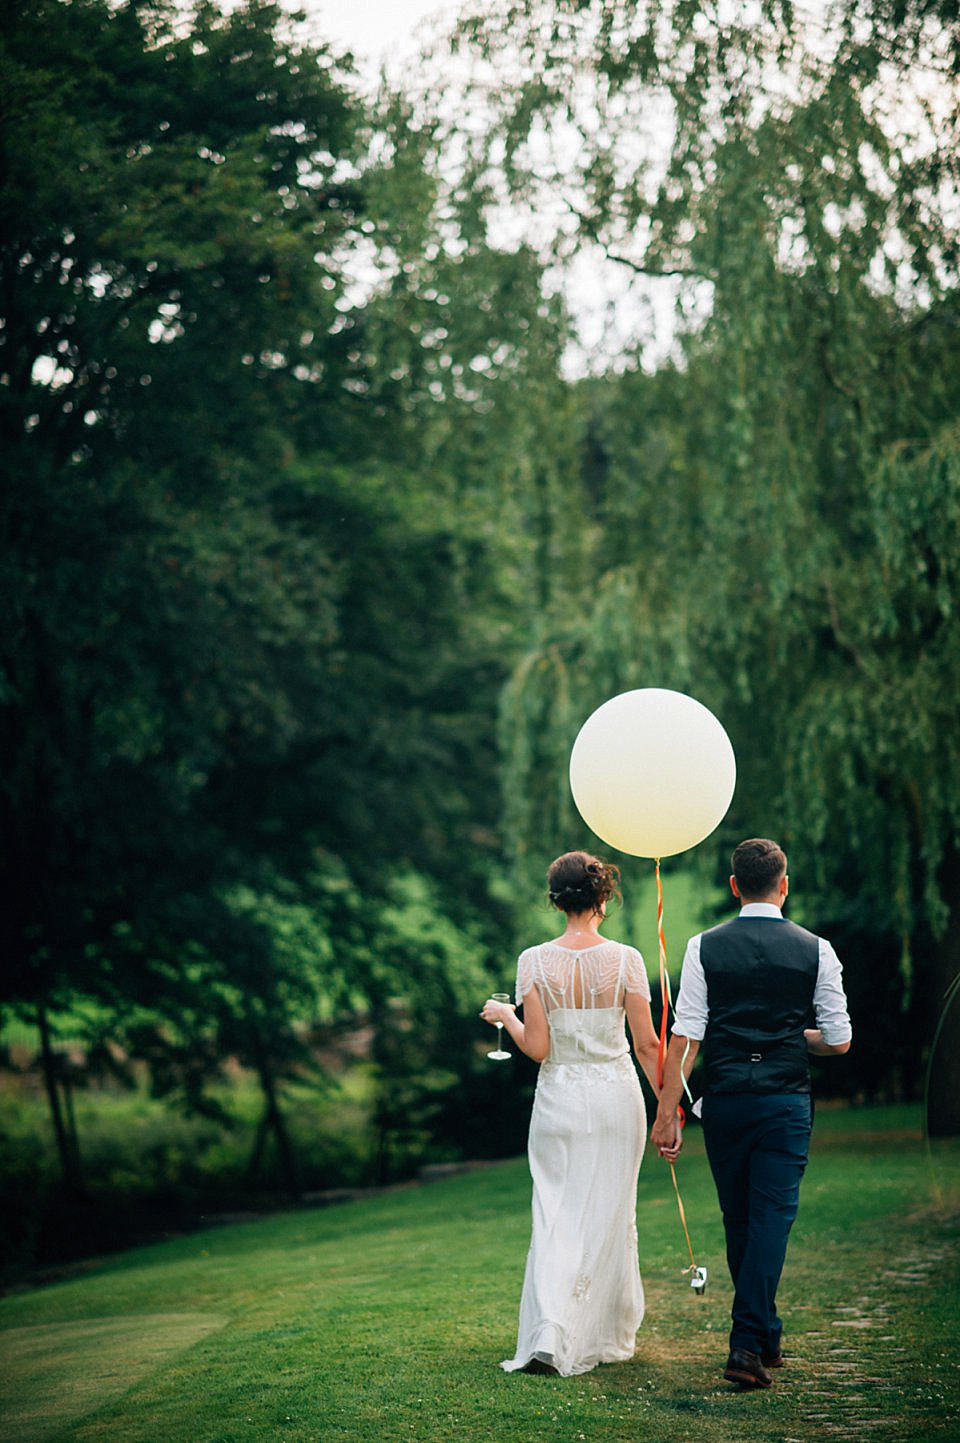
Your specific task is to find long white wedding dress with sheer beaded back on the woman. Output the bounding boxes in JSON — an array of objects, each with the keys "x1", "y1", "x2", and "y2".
[{"x1": 501, "y1": 942, "x2": 650, "y2": 1377}]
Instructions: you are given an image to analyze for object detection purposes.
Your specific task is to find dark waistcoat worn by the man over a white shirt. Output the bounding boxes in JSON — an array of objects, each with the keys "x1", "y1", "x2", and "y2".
[{"x1": 700, "y1": 916, "x2": 820, "y2": 1094}]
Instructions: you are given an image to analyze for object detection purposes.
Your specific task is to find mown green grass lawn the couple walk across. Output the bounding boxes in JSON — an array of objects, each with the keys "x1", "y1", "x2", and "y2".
[{"x1": 0, "y1": 1108, "x2": 960, "y2": 1443}]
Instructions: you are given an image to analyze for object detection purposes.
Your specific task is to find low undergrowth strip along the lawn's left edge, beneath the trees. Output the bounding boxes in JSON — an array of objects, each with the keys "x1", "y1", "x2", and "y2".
[{"x1": 0, "y1": 1065, "x2": 375, "y2": 1286}]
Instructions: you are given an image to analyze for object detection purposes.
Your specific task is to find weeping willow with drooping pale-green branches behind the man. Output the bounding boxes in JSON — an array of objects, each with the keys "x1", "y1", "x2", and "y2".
[{"x1": 441, "y1": 0, "x2": 960, "y2": 1131}]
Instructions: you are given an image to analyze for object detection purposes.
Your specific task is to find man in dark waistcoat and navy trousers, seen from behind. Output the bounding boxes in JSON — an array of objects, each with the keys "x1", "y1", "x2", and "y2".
[{"x1": 651, "y1": 837, "x2": 852, "y2": 1388}]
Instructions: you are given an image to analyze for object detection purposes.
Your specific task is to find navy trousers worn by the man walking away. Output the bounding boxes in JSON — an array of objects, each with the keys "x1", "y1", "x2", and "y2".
[{"x1": 702, "y1": 1092, "x2": 811, "y2": 1356}]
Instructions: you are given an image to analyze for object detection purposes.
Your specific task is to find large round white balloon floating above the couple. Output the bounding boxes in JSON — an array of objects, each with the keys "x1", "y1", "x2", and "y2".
[{"x1": 570, "y1": 687, "x2": 736, "y2": 857}]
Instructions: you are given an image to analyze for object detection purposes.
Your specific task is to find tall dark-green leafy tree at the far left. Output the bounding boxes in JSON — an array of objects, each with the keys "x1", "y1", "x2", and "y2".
[{"x1": 0, "y1": 0, "x2": 368, "y2": 1173}]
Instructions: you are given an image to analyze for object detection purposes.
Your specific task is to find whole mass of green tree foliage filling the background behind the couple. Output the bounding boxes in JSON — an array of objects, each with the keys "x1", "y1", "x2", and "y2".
[{"x1": 7, "y1": 0, "x2": 960, "y2": 1240}]
